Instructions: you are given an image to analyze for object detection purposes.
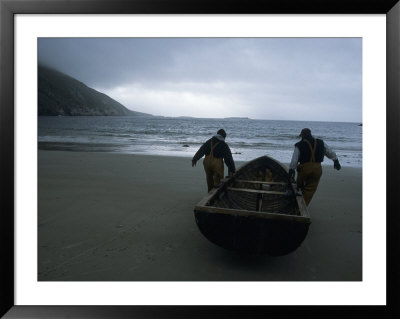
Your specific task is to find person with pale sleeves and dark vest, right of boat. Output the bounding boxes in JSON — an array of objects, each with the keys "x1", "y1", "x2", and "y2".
[{"x1": 289, "y1": 128, "x2": 341, "y2": 206}]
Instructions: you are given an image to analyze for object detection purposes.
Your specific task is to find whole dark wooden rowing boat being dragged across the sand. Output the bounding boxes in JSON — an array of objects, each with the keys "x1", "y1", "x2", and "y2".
[{"x1": 194, "y1": 156, "x2": 311, "y2": 256}]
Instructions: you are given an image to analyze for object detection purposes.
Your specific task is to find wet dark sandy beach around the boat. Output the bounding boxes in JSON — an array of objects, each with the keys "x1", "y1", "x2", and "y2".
[{"x1": 38, "y1": 150, "x2": 362, "y2": 281}]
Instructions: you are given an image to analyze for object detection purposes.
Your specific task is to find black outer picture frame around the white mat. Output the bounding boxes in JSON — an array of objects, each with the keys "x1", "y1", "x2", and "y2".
[{"x1": 0, "y1": 0, "x2": 400, "y2": 318}]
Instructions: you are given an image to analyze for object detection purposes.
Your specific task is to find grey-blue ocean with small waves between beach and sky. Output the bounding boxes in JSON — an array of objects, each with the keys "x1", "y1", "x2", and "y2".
[{"x1": 38, "y1": 116, "x2": 362, "y2": 167}]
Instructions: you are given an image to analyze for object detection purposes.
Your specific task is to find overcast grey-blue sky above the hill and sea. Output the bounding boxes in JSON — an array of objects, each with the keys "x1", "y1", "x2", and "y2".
[{"x1": 38, "y1": 38, "x2": 362, "y2": 122}]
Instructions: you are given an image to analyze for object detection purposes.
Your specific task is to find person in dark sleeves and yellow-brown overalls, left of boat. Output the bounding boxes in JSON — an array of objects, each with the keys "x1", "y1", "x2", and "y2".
[{"x1": 192, "y1": 129, "x2": 236, "y2": 191}]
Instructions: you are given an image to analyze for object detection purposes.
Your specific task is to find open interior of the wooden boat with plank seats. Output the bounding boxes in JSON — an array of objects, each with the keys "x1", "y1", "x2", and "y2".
[{"x1": 196, "y1": 156, "x2": 309, "y2": 218}]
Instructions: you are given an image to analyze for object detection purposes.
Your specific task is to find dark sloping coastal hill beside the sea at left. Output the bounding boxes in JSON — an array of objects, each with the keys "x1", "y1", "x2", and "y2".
[{"x1": 38, "y1": 65, "x2": 151, "y2": 116}]
